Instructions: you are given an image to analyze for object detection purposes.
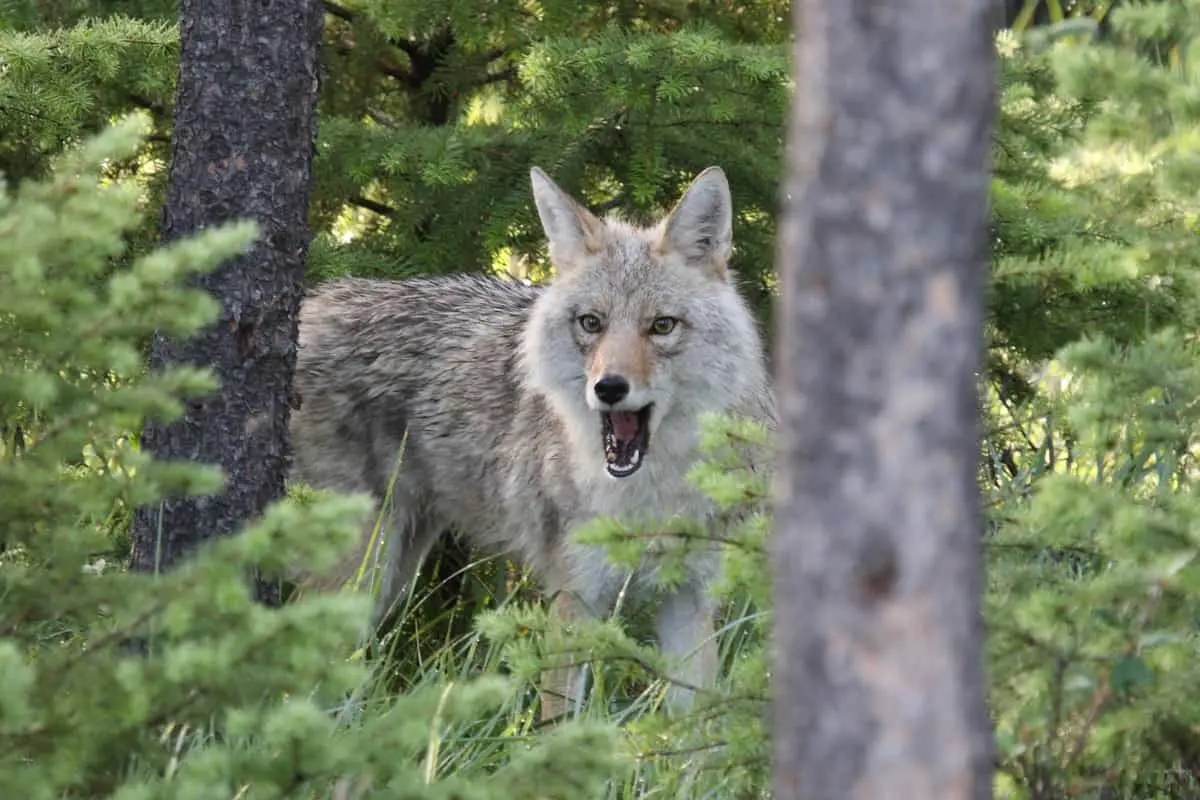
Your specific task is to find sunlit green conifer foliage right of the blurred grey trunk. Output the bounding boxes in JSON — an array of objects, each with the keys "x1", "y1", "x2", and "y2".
[{"x1": 984, "y1": 0, "x2": 1200, "y2": 798}]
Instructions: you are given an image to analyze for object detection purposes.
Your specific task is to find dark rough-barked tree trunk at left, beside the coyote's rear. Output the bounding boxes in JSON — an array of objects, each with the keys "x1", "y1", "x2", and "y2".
[{"x1": 132, "y1": 0, "x2": 323, "y2": 601}]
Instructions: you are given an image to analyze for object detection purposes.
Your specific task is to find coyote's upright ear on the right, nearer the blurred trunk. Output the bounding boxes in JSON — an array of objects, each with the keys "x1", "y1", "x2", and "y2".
[{"x1": 659, "y1": 167, "x2": 733, "y2": 278}]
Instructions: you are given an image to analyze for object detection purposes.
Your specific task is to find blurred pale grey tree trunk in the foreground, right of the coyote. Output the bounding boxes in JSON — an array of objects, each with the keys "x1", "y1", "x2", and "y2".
[{"x1": 773, "y1": 0, "x2": 994, "y2": 800}]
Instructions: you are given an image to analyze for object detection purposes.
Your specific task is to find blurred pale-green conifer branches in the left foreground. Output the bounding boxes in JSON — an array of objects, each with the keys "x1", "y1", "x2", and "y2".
[{"x1": 0, "y1": 120, "x2": 619, "y2": 800}]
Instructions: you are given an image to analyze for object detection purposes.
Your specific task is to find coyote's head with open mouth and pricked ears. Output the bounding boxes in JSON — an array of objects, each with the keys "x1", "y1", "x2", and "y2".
[{"x1": 522, "y1": 167, "x2": 762, "y2": 479}]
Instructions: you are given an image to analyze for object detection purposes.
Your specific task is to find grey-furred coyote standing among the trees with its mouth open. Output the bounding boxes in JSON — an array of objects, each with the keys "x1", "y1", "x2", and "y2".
[{"x1": 292, "y1": 167, "x2": 775, "y2": 717}]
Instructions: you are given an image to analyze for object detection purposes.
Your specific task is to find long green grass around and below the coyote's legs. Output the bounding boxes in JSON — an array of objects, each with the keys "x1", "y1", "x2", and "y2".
[{"x1": 236, "y1": 472, "x2": 768, "y2": 800}]
